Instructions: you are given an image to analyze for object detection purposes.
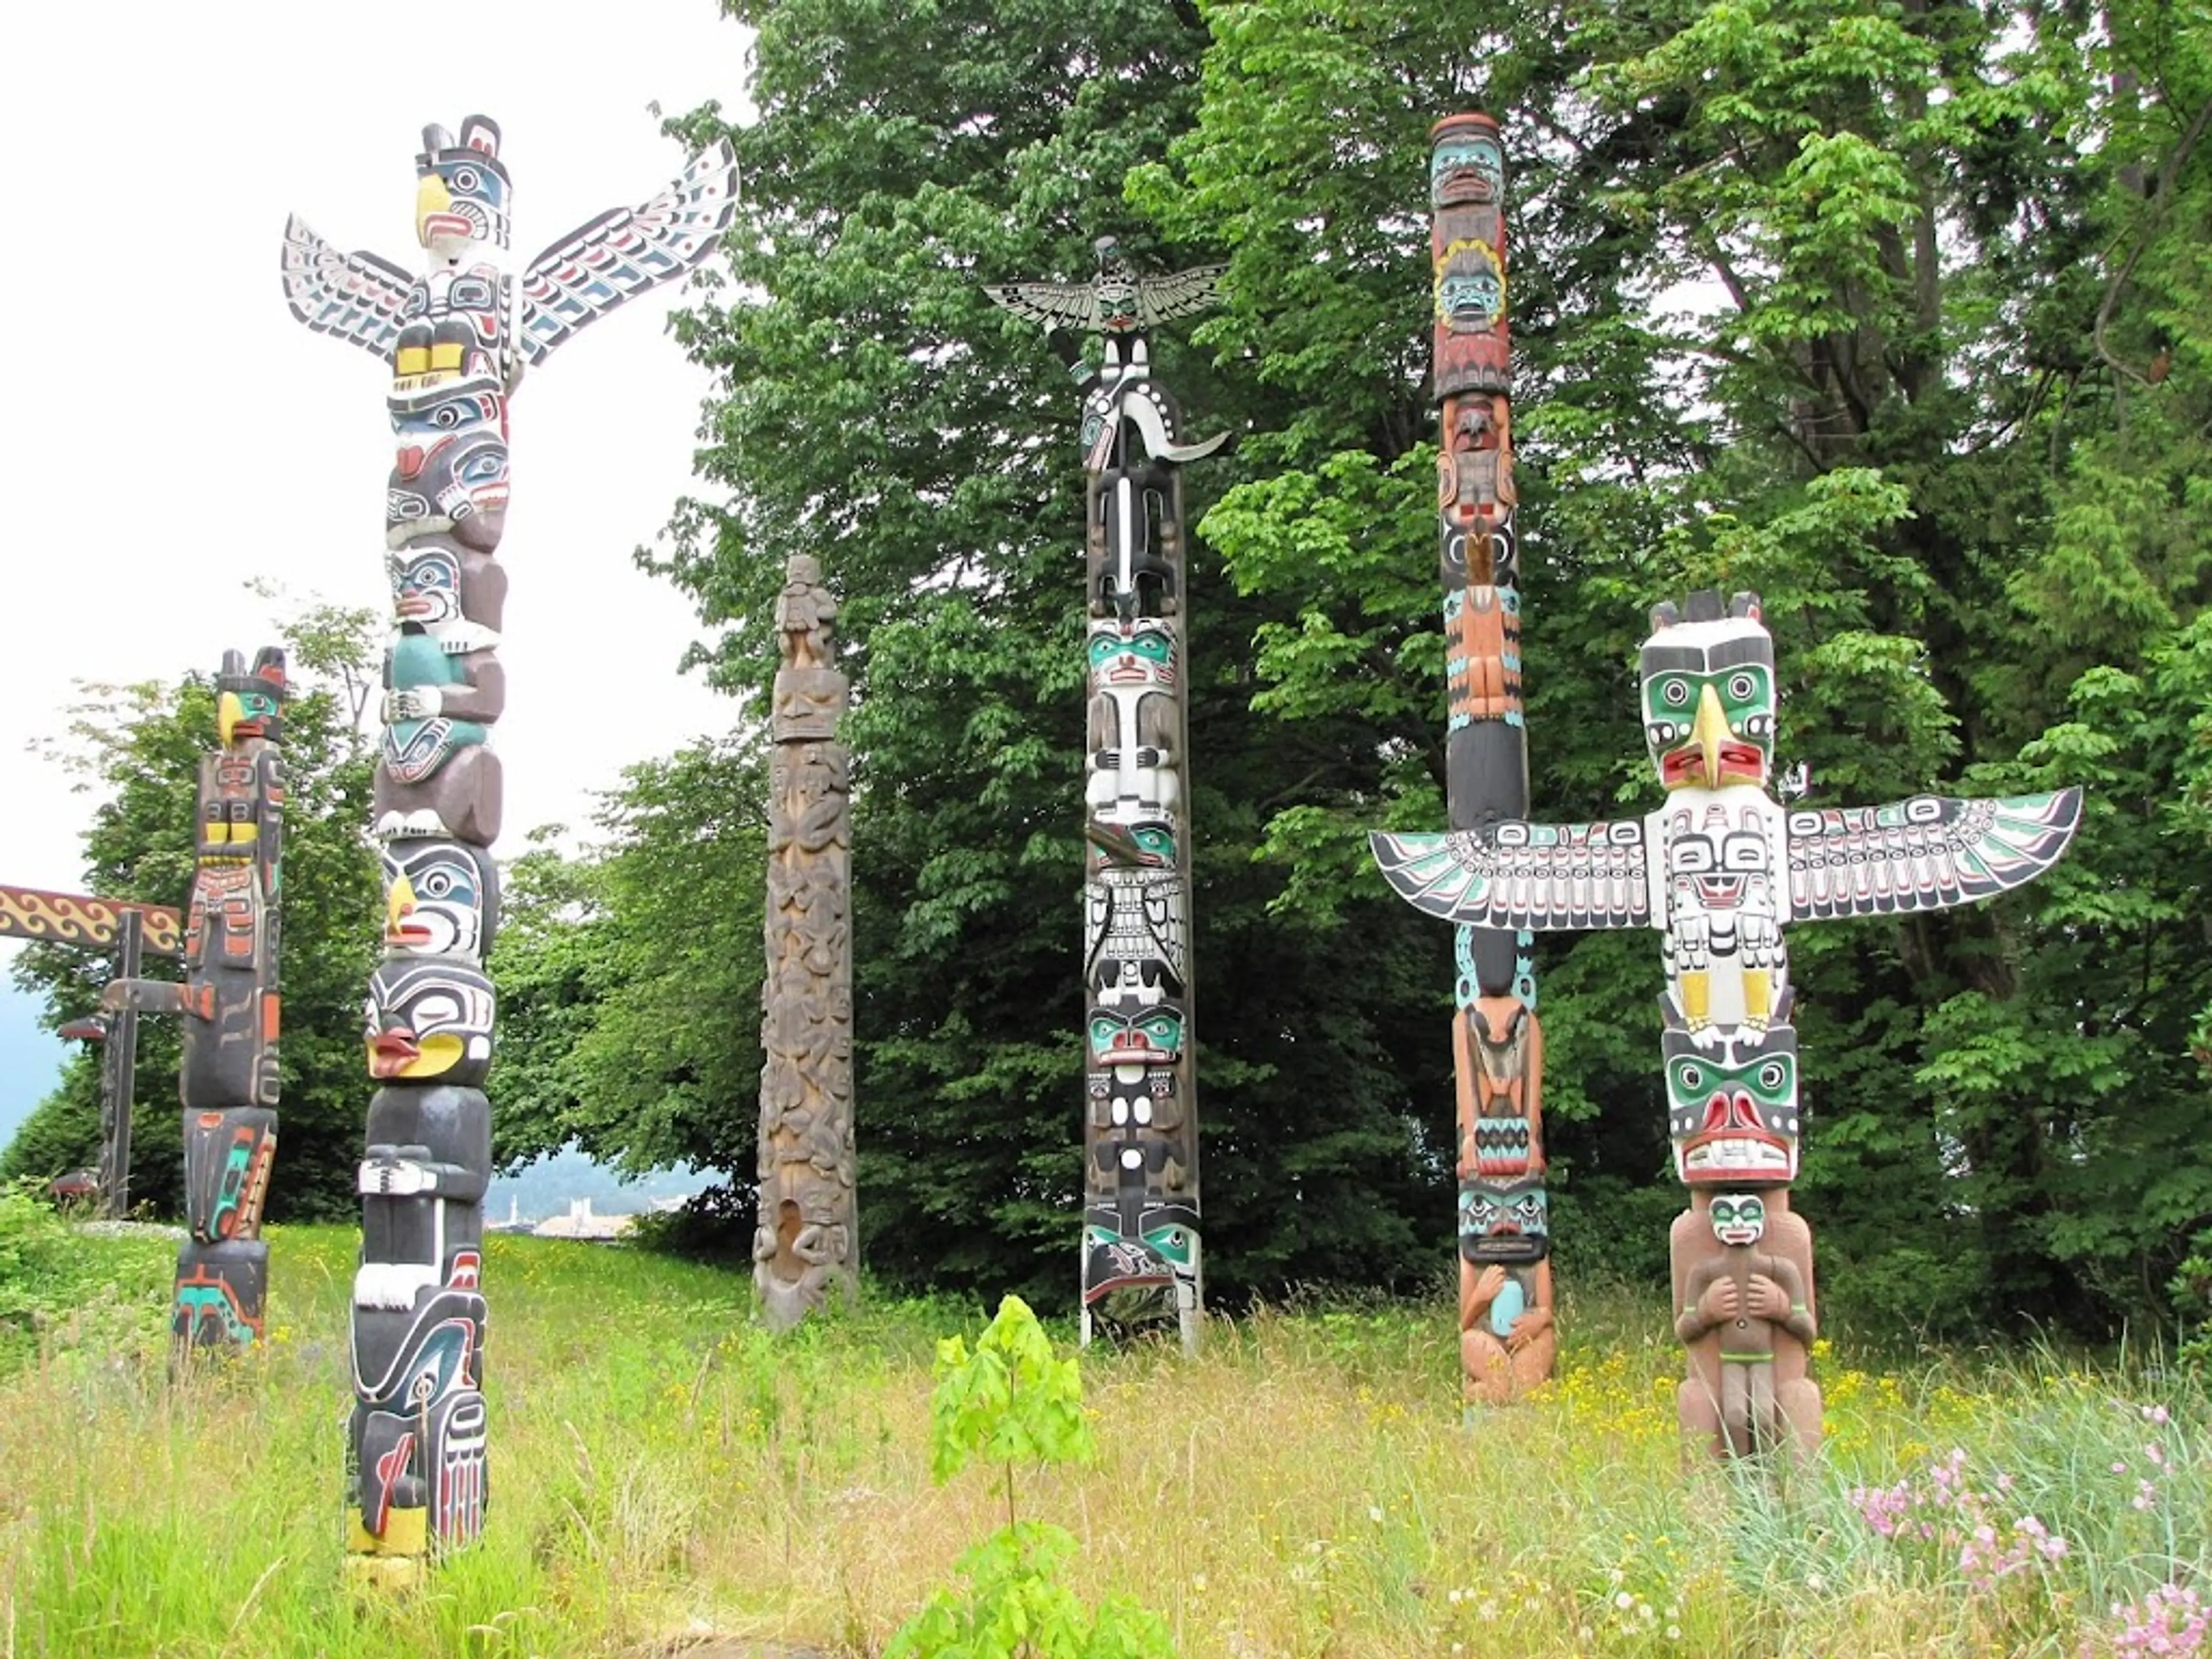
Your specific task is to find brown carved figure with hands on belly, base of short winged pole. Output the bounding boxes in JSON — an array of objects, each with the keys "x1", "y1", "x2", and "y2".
[{"x1": 1672, "y1": 1192, "x2": 1820, "y2": 1458}]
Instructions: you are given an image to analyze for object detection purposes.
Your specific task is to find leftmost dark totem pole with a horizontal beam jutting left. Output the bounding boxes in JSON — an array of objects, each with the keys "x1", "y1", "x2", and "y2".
[{"x1": 100, "y1": 646, "x2": 285, "y2": 1347}]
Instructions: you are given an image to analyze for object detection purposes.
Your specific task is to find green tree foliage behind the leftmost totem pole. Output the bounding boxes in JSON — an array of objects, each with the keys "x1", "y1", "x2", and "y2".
[{"x1": 0, "y1": 606, "x2": 380, "y2": 1219}]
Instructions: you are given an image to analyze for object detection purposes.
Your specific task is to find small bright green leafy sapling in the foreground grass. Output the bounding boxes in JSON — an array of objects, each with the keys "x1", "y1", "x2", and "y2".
[{"x1": 885, "y1": 1296, "x2": 1175, "y2": 1659}]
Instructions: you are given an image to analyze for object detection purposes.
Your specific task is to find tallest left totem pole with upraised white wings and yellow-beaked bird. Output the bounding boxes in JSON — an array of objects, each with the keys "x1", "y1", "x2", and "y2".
[{"x1": 283, "y1": 115, "x2": 737, "y2": 1584}]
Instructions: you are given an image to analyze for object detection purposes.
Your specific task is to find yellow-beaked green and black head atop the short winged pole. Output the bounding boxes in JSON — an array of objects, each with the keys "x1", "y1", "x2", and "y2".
[{"x1": 1641, "y1": 617, "x2": 1777, "y2": 790}]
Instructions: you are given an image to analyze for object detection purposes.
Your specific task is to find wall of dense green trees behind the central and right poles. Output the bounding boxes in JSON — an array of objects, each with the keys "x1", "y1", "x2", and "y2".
[{"x1": 484, "y1": 0, "x2": 2212, "y2": 1330}]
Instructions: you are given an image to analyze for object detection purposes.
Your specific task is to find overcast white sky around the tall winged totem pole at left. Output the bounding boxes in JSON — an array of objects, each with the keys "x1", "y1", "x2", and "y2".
[{"x1": 0, "y1": 0, "x2": 750, "y2": 1106}]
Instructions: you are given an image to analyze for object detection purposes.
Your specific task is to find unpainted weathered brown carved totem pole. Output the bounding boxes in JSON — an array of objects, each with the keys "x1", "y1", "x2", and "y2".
[{"x1": 752, "y1": 553, "x2": 861, "y2": 1330}]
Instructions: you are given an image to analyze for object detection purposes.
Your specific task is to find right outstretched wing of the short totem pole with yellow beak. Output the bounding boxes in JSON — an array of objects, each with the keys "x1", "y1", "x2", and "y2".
[{"x1": 1787, "y1": 790, "x2": 2081, "y2": 920}]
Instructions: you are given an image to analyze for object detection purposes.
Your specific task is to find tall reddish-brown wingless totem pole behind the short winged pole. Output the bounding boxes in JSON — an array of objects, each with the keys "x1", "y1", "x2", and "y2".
[{"x1": 1429, "y1": 115, "x2": 1559, "y2": 1404}]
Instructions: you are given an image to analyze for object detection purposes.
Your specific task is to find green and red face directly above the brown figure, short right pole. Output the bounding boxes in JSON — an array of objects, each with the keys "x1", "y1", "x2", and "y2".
[{"x1": 1659, "y1": 1027, "x2": 1798, "y2": 1188}]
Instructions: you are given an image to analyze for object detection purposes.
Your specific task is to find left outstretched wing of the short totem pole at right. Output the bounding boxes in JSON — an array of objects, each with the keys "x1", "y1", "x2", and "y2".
[{"x1": 1367, "y1": 819, "x2": 1666, "y2": 931}]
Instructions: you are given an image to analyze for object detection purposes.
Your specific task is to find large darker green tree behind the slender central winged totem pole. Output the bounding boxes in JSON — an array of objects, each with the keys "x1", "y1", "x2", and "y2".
[{"x1": 615, "y1": 0, "x2": 1451, "y2": 1305}]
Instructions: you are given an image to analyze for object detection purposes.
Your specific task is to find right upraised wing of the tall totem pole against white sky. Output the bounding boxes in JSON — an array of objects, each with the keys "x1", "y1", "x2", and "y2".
[{"x1": 522, "y1": 139, "x2": 737, "y2": 365}]
